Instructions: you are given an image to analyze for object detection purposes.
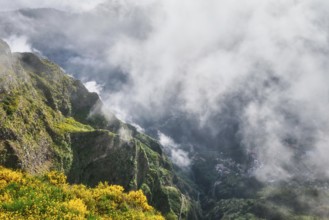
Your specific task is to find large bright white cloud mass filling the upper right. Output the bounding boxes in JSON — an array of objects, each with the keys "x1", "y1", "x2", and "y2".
[{"x1": 104, "y1": 0, "x2": 329, "y2": 180}]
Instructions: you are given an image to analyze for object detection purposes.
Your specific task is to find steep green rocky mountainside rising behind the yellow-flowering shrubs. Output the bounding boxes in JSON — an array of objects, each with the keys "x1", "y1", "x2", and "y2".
[{"x1": 0, "y1": 40, "x2": 198, "y2": 219}]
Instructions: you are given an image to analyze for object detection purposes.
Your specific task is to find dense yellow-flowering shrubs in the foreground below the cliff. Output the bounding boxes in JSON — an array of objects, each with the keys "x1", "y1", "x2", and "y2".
[{"x1": 0, "y1": 167, "x2": 164, "y2": 220}]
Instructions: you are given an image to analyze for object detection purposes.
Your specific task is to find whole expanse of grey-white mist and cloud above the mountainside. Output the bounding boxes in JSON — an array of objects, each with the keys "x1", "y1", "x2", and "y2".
[{"x1": 0, "y1": 0, "x2": 329, "y2": 182}]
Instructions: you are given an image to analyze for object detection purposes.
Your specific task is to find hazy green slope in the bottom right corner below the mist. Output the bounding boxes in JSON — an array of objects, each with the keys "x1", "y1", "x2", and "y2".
[{"x1": 207, "y1": 183, "x2": 329, "y2": 220}]
